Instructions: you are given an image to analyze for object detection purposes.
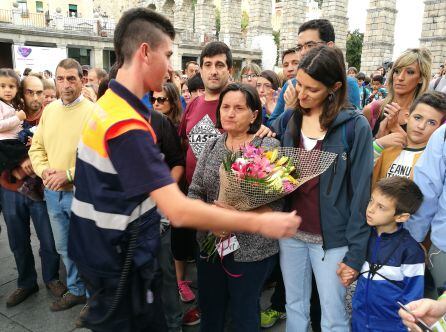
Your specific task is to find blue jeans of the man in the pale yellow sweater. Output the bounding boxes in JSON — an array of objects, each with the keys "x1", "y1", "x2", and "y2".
[{"x1": 45, "y1": 189, "x2": 85, "y2": 296}]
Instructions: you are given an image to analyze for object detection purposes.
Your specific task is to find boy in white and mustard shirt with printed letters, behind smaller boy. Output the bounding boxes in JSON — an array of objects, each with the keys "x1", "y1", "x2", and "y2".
[{"x1": 372, "y1": 91, "x2": 446, "y2": 183}]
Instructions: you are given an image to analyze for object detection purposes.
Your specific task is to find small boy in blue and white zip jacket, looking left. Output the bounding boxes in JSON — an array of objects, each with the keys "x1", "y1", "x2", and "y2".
[{"x1": 340, "y1": 177, "x2": 425, "y2": 332}]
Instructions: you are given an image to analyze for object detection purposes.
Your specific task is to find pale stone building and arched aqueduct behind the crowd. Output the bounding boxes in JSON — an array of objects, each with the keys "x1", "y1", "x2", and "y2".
[{"x1": 0, "y1": 0, "x2": 446, "y2": 73}]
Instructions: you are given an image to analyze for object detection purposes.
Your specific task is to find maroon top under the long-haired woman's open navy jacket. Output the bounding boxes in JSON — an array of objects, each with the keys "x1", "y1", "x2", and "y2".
[{"x1": 291, "y1": 138, "x2": 322, "y2": 235}]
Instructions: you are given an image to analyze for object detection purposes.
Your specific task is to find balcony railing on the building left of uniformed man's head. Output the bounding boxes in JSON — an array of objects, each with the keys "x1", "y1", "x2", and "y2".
[{"x1": 0, "y1": 10, "x2": 115, "y2": 37}]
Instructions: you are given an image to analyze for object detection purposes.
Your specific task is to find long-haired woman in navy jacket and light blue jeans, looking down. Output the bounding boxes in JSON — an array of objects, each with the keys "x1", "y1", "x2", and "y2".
[{"x1": 273, "y1": 46, "x2": 373, "y2": 332}]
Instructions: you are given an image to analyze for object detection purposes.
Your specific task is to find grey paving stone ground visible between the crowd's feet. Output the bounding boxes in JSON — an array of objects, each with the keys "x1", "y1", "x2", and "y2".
[{"x1": 0, "y1": 216, "x2": 285, "y2": 332}]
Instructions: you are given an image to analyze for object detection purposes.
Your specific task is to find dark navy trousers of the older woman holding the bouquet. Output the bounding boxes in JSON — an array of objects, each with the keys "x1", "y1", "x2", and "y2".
[{"x1": 197, "y1": 254, "x2": 277, "y2": 332}]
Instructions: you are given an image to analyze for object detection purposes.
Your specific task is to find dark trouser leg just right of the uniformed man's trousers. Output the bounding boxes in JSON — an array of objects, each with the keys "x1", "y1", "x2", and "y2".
[{"x1": 158, "y1": 227, "x2": 183, "y2": 332}]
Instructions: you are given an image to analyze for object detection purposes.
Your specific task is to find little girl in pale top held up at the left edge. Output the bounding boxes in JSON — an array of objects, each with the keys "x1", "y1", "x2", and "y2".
[{"x1": 0, "y1": 68, "x2": 43, "y2": 200}]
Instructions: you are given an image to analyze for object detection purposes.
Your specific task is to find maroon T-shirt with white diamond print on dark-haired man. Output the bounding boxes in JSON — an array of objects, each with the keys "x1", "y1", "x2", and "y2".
[{"x1": 178, "y1": 96, "x2": 220, "y2": 184}]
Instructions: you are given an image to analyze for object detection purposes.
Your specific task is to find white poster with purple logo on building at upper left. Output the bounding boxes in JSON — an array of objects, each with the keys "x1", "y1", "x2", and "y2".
[{"x1": 14, "y1": 45, "x2": 67, "y2": 74}]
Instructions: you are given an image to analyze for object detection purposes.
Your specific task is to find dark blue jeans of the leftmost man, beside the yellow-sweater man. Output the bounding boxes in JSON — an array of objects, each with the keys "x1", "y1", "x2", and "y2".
[{"x1": 0, "y1": 188, "x2": 59, "y2": 288}]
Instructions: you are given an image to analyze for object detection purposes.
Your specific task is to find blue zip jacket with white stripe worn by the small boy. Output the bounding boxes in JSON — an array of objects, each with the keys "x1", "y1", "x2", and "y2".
[{"x1": 352, "y1": 227, "x2": 424, "y2": 332}]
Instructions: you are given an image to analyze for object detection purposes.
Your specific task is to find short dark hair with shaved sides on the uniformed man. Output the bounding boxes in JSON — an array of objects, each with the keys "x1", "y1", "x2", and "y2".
[{"x1": 113, "y1": 7, "x2": 175, "y2": 67}]
